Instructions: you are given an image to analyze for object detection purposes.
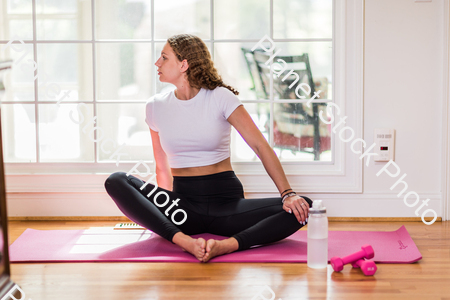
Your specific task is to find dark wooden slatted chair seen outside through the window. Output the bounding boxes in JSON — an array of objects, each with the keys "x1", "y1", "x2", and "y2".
[{"x1": 241, "y1": 48, "x2": 331, "y2": 160}]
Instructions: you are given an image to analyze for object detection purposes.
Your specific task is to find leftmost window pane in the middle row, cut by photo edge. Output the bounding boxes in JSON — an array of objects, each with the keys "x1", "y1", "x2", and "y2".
[{"x1": 0, "y1": 43, "x2": 34, "y2": 101}]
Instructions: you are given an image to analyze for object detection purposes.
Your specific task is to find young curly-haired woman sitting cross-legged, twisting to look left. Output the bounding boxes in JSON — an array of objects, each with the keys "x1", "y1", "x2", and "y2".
[{"x1": 105, "y1": 34, "x2": 312, "y2": 262}]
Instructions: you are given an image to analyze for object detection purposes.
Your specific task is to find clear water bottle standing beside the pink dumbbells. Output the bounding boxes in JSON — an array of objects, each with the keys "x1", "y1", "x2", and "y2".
[{"x1": 307, "y1": 200, "x2": 328, "y2": 269}]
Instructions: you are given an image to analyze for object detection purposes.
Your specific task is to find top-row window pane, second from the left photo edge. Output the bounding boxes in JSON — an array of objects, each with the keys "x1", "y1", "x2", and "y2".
[{"x1": 36, "y1": 0, "x2": 92, "y2": 40}]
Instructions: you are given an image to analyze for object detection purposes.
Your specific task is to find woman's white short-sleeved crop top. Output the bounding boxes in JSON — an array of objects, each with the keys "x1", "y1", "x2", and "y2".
[{"x1": 145, "y1": 87, "x2": 242, "y2": 168}]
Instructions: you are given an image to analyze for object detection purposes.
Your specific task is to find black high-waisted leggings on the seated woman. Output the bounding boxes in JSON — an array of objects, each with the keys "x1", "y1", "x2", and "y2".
[{"x1": 105, "y1": 171, "x2": 312, "y2": 250}]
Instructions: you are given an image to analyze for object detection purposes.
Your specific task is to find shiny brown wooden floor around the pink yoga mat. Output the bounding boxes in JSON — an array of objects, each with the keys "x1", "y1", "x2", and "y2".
[{"x1": 9, "y1": 221, "x2": 450, "y2": 300}]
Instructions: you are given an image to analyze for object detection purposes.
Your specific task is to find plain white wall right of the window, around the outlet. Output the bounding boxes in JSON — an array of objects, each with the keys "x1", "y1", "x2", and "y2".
[{"x1": 364, "y1": 0, "x2": 444, "y2": 215}]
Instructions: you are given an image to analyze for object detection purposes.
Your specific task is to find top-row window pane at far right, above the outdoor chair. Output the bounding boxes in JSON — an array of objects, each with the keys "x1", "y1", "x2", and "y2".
[{"x1": 273, "y1": 0, "x2": 333, "y2": 39}]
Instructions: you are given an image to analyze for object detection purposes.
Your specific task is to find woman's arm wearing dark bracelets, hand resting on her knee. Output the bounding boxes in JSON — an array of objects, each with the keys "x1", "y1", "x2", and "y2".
[{"x1": 227, "y1": 105, "x2": 309, "y2": 222}]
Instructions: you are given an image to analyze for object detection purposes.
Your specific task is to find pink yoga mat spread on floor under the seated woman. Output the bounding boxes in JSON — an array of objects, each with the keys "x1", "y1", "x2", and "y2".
[{"x1": 10, "y1": 226, "x2": 422, "y2": 263}]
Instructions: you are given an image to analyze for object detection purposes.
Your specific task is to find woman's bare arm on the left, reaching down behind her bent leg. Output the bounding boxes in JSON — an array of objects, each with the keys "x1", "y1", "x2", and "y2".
[{"x1": 150, "y1": 128, "x2": 173, "y2": 191}]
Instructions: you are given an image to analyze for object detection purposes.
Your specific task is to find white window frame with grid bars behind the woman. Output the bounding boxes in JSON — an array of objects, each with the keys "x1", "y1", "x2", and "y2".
[{"x1": 0, "y1": 0, "x2": 364, "y2": 195}]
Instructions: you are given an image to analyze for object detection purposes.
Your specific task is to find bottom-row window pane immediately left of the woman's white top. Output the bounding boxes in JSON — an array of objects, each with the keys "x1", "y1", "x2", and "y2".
[{"x1": 97, "y1": 103, "x2": 153, "y2": 163}]
